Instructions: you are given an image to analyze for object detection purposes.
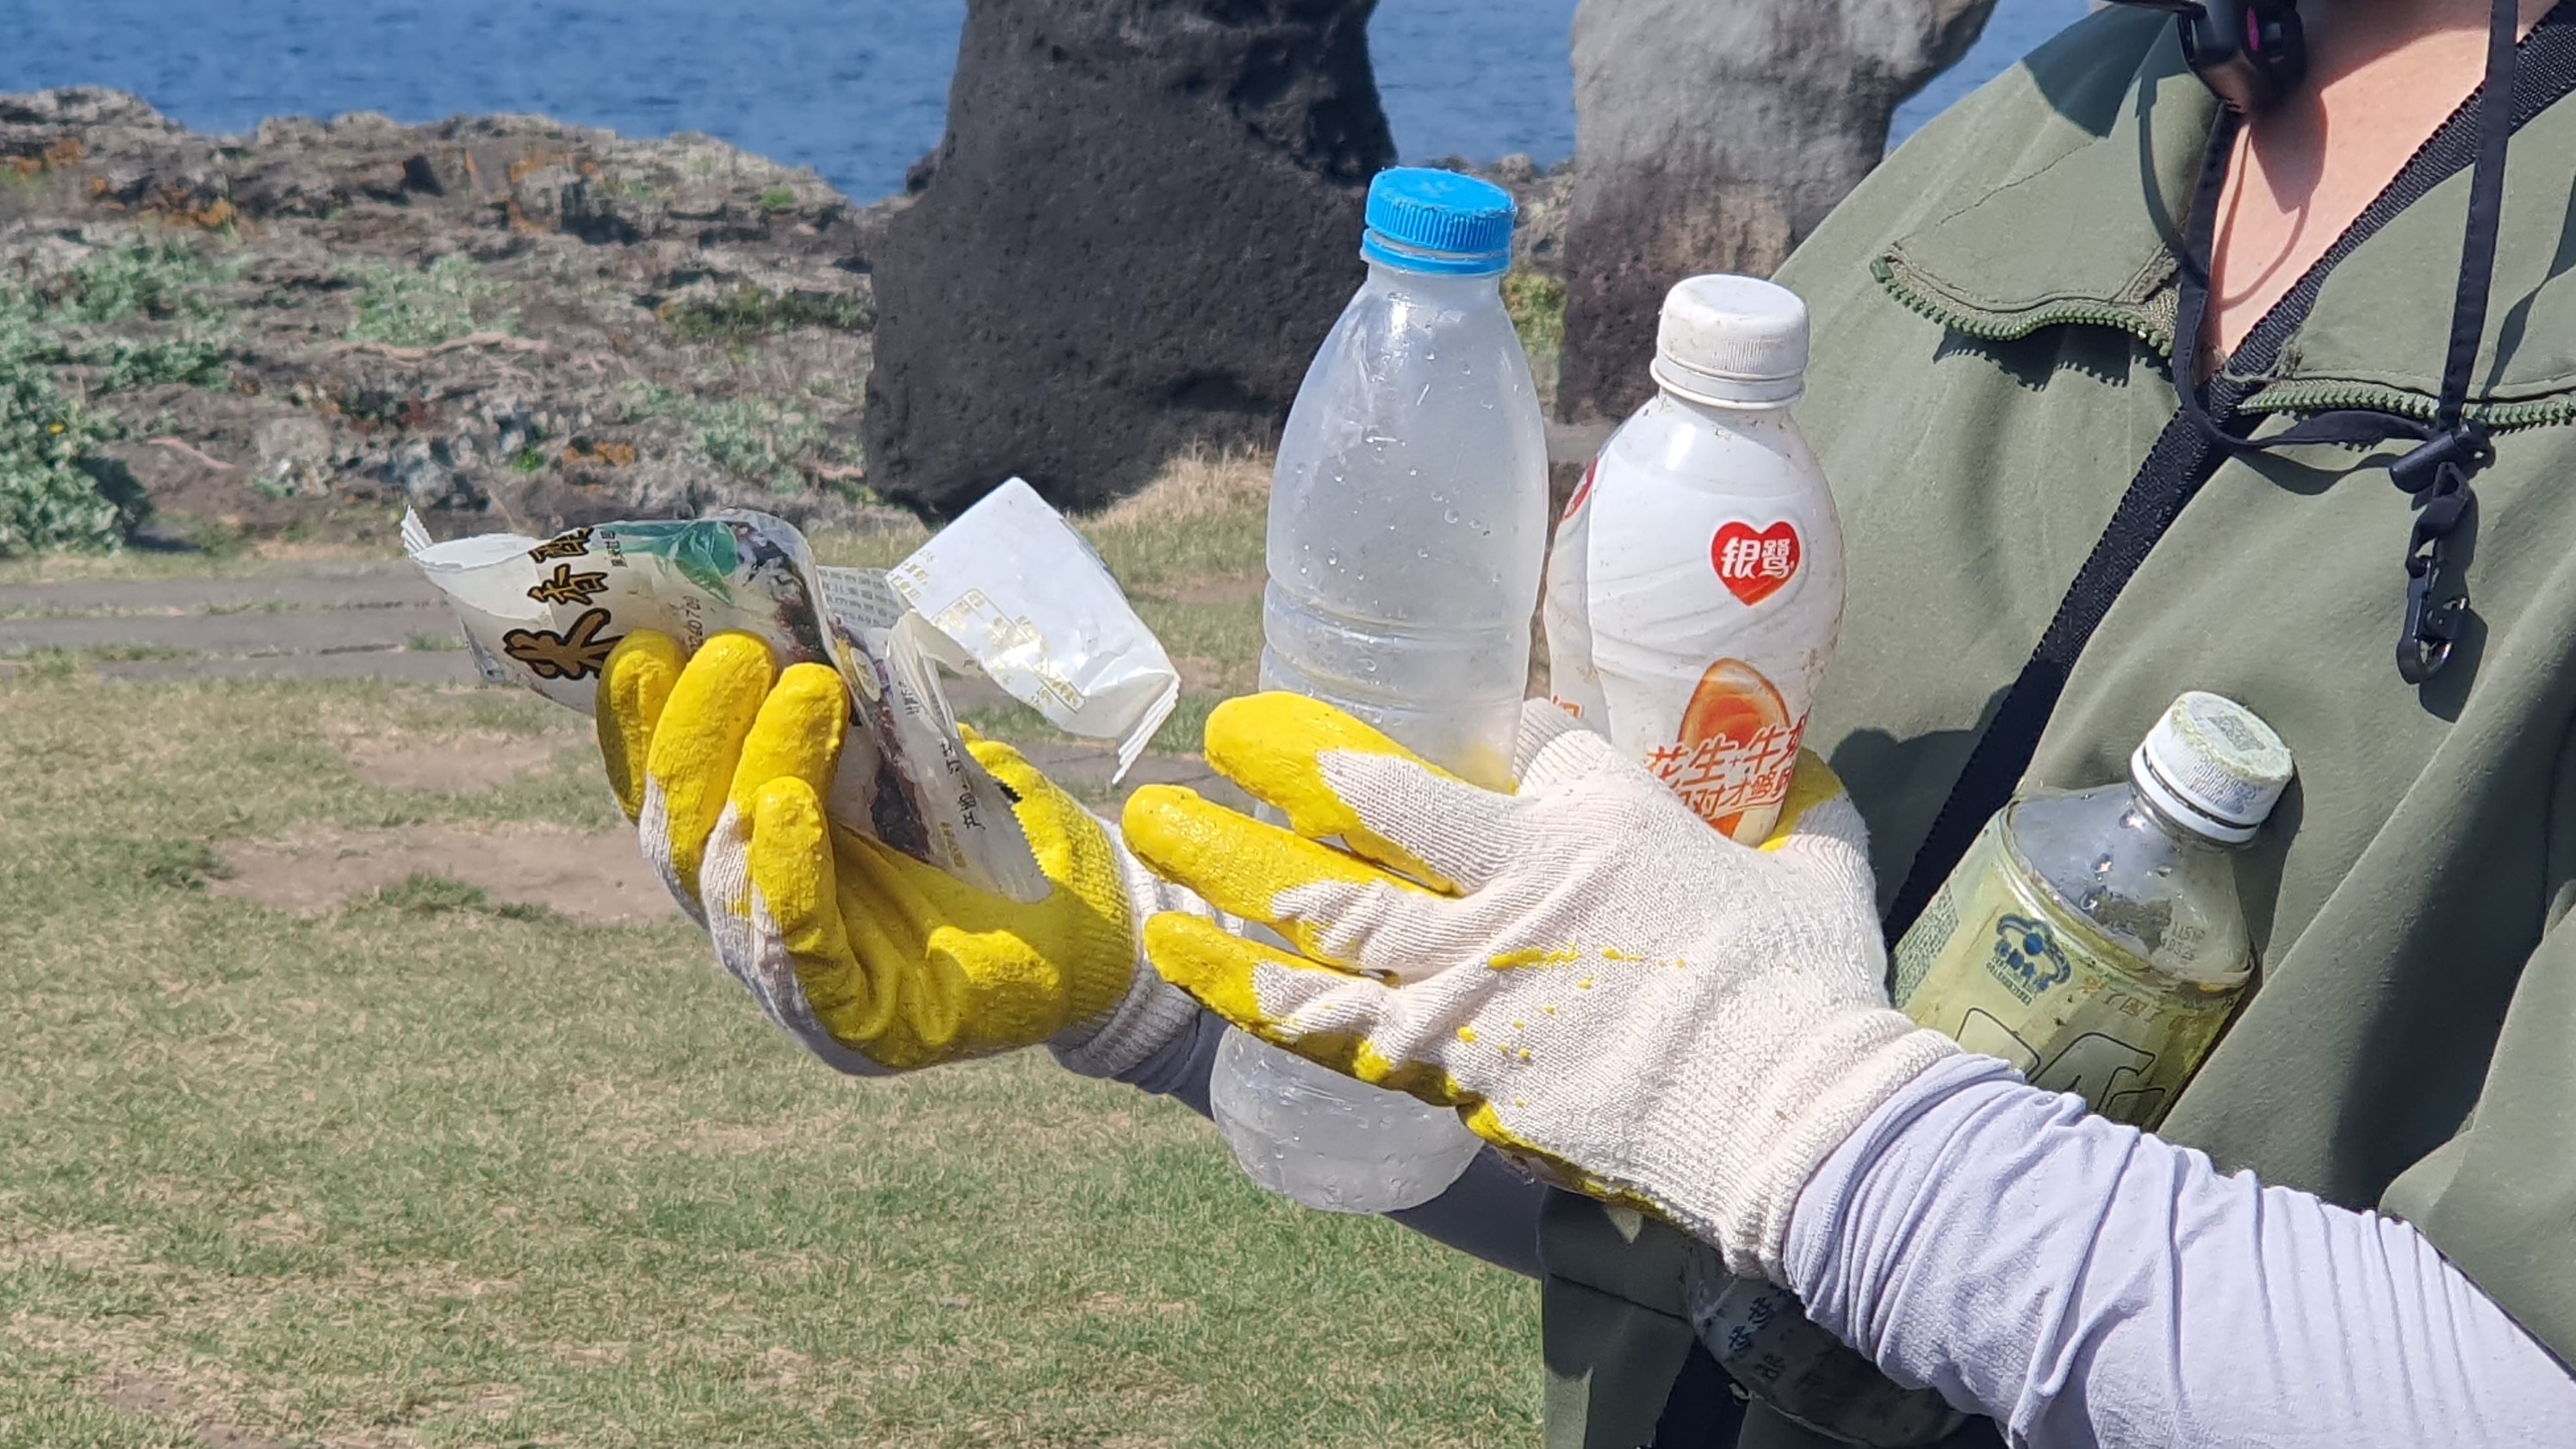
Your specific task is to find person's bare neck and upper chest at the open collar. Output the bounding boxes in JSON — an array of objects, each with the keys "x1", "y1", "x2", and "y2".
[{"x1": 2202, "y1": 0, "x2": 2555, "y2": 368}]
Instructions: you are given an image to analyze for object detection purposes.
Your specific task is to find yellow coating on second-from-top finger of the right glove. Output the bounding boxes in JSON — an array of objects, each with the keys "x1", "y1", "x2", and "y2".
[{"x1": 1120, "y1": 785, "x2": 1427, "y2": 965}]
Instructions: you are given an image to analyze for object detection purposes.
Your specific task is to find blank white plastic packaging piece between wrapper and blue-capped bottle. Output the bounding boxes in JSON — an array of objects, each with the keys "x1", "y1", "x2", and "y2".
[{"x1": 886, "y1": 479, "x2": 1180, "y2": 777}]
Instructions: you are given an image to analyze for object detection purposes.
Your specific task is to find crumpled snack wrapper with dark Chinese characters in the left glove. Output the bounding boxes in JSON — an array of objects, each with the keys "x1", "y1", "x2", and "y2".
[{"x1": 402, "y1": 505, "x2": 1048, "y2": 901}]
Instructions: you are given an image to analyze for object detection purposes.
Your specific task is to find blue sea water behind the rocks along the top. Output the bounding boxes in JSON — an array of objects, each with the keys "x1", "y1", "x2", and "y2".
[{"x1": 0, "y1": 0, "x2": 2087, "y2": 198}]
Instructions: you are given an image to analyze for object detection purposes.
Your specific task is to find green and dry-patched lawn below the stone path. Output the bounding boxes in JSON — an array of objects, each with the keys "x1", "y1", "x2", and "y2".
[{"x1": 0, "y1": 674, "x2": 1541, "y2": 1449}]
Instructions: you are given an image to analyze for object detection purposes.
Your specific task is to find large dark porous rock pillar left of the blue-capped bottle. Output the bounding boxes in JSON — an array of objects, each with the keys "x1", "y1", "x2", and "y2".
[{"x1": 866, "y1": 0, "x2": 1394, "y2": 512}]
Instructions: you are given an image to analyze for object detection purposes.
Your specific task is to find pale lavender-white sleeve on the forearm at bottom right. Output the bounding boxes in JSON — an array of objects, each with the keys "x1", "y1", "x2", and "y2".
[{"x1": 1788, "y1": 1058, "x2": 2576, "y2": 1449}]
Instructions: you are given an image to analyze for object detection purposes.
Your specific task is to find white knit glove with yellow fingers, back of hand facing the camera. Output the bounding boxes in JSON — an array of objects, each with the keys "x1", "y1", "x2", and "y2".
[{"x1": 1126, "y1": 695, "x2": 1958, "y2": 1279}]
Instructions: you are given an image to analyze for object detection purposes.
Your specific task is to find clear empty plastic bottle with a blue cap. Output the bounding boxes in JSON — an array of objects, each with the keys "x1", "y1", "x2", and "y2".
[{"x1": 1211, "y1": 170, "x2": 1549, "y2": 1212}]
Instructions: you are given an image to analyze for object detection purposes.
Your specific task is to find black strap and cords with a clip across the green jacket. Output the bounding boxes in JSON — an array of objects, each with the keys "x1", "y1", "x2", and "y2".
[{"x1": 1888, "y1": 0, "x2": 2576, "y2": 942}]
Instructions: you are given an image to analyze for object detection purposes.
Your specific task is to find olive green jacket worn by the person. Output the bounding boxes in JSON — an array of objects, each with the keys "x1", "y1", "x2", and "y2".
[{"x1": 1543, "y1": 8, "x2": 2576, "y2": 1449}]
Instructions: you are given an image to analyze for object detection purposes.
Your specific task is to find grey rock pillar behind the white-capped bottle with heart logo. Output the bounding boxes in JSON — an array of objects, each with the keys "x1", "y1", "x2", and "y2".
[{"x1": 1556, "y1": 0, "x2": 1994, "y2": 419}]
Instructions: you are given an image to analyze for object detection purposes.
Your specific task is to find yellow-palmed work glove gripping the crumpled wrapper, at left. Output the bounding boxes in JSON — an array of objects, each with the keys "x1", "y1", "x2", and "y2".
[{"x1": 598, "y1": 633, "x2": 1195, "y2": 1076}]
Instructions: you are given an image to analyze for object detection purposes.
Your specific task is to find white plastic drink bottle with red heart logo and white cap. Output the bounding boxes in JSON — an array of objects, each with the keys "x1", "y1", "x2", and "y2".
[{"x1": 1546, "y1": 276, "x2": 1842, "y2": 845}]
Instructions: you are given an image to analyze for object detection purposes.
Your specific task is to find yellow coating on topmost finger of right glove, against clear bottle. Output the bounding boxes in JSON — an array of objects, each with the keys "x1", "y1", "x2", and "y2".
[{"x1": 1206, "y1": 692, "x2": 1456, "y2": 890}]
